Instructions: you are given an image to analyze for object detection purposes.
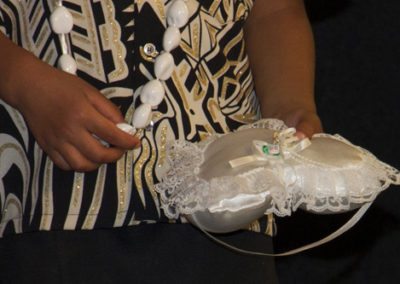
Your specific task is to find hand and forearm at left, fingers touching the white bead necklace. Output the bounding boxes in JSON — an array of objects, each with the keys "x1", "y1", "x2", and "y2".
[{"x1": 0, "y1": 32, "x2": 139, "y2": 171}]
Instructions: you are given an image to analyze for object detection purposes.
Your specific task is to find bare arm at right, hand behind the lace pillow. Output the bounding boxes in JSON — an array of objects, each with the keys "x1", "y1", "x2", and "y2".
[{"x1": 245, "y1": 0, "x2": 322, "y2": 136}]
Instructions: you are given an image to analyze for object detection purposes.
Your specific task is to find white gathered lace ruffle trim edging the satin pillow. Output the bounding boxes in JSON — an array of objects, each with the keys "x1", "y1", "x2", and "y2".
[{"x1": 156, "y1": 120, "x2": 400, "y2": 218}]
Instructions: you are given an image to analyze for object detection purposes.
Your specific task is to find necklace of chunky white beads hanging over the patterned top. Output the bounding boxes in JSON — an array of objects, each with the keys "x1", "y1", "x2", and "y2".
[{"x1": 50, "y1": 0, "x2": 189, "y2": 135}]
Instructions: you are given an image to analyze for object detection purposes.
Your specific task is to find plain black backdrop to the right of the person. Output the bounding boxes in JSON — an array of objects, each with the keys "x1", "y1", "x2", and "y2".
[{"x1": 275, "y1": 0, "x2": 400, "y2": 283}]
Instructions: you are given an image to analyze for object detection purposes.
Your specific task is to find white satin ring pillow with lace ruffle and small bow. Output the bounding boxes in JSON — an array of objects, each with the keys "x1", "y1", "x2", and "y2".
[{"x1": 156, "y1": 119, "x2": 400, "y2": 233}]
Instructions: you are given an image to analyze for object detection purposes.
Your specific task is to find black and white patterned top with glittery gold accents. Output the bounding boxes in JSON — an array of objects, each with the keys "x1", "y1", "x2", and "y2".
[{"x1": 0, "y1": 0, "x2": 259, "y2": 237}]
